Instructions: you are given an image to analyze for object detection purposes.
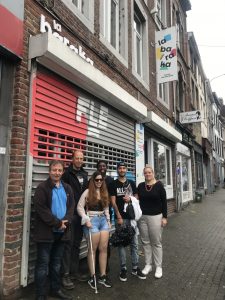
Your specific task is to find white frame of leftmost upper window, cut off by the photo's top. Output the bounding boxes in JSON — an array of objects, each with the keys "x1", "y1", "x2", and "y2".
[{"x1": 62, "y1": 0, "x2": 94, "y2": 33}]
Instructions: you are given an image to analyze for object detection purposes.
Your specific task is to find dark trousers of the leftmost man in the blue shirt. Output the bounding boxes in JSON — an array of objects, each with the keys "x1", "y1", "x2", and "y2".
[{"x1": 35, "y1": 234, "x2": 65, "y2": 296}]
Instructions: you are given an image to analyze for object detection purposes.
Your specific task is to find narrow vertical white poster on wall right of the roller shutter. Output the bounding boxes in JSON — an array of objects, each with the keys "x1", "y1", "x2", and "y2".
[{"x1": 135, "y1": 124, "x2": 145, "y2": 185}]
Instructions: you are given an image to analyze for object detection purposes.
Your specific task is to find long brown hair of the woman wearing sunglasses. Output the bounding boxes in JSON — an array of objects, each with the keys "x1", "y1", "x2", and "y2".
[{"x1": 87, "y1": 171, "x2": 109, "y2": 208}]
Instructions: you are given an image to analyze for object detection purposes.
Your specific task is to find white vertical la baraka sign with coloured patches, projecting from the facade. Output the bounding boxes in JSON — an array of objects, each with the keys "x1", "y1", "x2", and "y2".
[{"x1": 155, "y1": 27, "x2": 177, "y2": 84}]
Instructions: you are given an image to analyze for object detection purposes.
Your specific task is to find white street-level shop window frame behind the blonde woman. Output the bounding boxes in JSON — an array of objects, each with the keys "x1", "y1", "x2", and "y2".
[{"x1": 148, "y1": 138, "x2": 174, "y2": 199}]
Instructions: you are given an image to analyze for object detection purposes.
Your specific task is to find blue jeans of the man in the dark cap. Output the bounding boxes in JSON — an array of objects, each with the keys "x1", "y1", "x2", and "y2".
[{"x1": 116, "y1": 219, "x2": 139, "y2": 270}]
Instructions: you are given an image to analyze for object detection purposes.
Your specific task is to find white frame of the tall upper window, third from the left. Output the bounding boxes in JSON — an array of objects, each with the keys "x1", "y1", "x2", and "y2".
[{"x1": 131, "y1": 0, "x2": 150, "y2": 90}]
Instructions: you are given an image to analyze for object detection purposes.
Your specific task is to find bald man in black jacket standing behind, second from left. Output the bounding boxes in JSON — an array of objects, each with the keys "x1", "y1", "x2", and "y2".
[{"x1": 62, "y1": 150, "x2": 88, "y2": 289}]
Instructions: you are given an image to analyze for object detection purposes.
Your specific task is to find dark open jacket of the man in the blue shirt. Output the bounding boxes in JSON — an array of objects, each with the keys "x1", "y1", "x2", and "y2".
[{"x1": 34, "y1": 178, "x2": 75, "y2": 242}]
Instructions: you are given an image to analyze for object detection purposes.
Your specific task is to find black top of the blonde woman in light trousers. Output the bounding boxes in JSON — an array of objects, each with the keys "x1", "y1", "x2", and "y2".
[{"x1": 138, "y1": 181, "x2": 167, "y2": 218}]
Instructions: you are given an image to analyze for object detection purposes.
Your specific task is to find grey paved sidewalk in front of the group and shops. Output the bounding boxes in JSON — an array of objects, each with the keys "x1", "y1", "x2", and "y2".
[{"x1": 20, "y1": 189, "x2": 225, "y2": 300}]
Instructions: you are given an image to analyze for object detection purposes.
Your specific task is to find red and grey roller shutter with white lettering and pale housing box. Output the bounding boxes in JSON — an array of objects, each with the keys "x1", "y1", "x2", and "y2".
[{"x1": 21, "y1": 21, "x2": 147, "y2": 286}]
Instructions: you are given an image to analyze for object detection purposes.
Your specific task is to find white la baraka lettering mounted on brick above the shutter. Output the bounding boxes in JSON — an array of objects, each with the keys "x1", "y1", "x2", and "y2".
[{"x1": 40, "y1": 15, "x2": 94, "y2": 66}]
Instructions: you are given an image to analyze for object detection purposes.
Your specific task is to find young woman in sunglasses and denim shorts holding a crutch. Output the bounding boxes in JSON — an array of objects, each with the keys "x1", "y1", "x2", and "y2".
[{"x1": 77, "y1": 171, "x2": 111, "y2": 289}]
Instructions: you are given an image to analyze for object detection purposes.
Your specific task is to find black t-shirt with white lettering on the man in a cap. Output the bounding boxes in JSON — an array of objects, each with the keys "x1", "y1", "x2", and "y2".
[{"x1": 109, "y1": 179, "x2": 137, "y2": 219}]
